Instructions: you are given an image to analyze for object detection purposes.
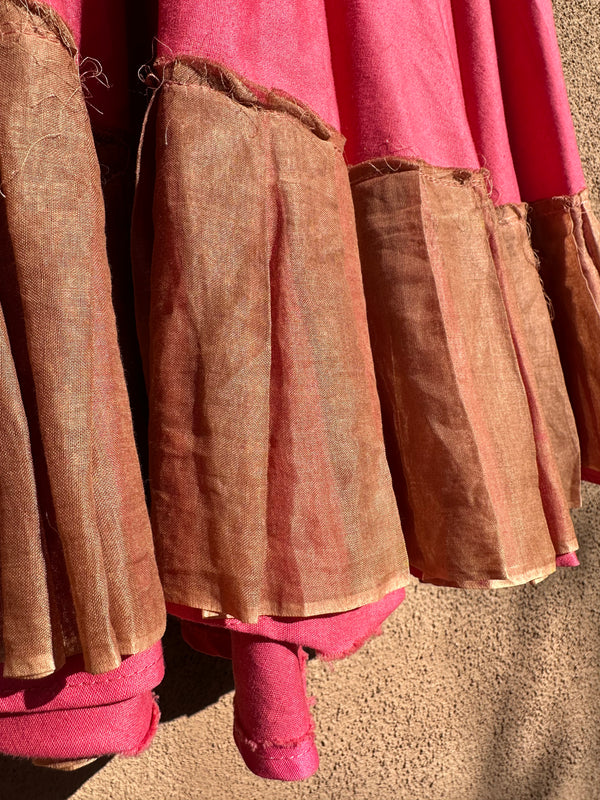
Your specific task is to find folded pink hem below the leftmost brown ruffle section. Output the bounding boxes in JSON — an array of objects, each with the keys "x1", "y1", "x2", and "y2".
[{"x1": 0, "y1": 642, "x2": 164, "y2": 760}]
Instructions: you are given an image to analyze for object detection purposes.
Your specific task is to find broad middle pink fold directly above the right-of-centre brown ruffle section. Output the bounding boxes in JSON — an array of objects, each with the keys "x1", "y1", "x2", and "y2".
[{"x1": 326, "y1": 0, "x2": 479, "y2": 169}]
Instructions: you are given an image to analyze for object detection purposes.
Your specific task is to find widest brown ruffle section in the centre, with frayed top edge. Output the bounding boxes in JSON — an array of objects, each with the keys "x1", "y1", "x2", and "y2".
[{"x1": 133, "y1": 59, "x2": 408, "y2": 622}]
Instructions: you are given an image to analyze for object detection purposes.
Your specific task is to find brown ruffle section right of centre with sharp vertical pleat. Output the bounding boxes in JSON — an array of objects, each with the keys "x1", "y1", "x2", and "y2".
[{"x1": 350, "y1": 159, "x2": 580, "y2": 587}]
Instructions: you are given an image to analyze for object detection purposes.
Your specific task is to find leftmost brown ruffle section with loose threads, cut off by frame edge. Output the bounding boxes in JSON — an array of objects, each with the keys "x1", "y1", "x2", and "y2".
[{"x1": 0, "y1": 0, "x2": 165, "y2": 678}]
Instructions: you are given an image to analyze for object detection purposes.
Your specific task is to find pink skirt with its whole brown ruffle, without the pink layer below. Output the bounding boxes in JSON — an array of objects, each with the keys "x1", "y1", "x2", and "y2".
[{"x1": 0, "y1": 0, "x2": 600, "y2": 692}]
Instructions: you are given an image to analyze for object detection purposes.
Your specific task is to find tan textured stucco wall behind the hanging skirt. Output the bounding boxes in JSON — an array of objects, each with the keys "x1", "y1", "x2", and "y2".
[{"x1": 0, "y1": 0, "x2": 600, "y2": 800}]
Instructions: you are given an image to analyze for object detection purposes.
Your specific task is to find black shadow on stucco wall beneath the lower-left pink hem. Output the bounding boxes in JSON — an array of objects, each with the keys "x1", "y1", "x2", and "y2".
[{"x1": 0, "y1": 617, "x2": 233, "y2": 800}]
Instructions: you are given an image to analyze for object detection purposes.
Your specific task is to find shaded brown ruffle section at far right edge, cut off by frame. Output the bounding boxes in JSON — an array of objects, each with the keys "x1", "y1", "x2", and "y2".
[{"x1": 530, "y1": 190, "x2": 600, "y2": 482}]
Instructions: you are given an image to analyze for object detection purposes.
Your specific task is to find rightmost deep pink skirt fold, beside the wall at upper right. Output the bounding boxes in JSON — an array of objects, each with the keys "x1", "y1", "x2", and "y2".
[{"x1": 491, "y1": 0, "x2": 585, "y2": 203}]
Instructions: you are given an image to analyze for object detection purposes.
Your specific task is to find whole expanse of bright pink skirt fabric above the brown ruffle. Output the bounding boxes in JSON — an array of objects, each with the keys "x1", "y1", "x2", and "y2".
[{"x1": 154, "y1": 0, "x2": 584, "y2": 204}]
